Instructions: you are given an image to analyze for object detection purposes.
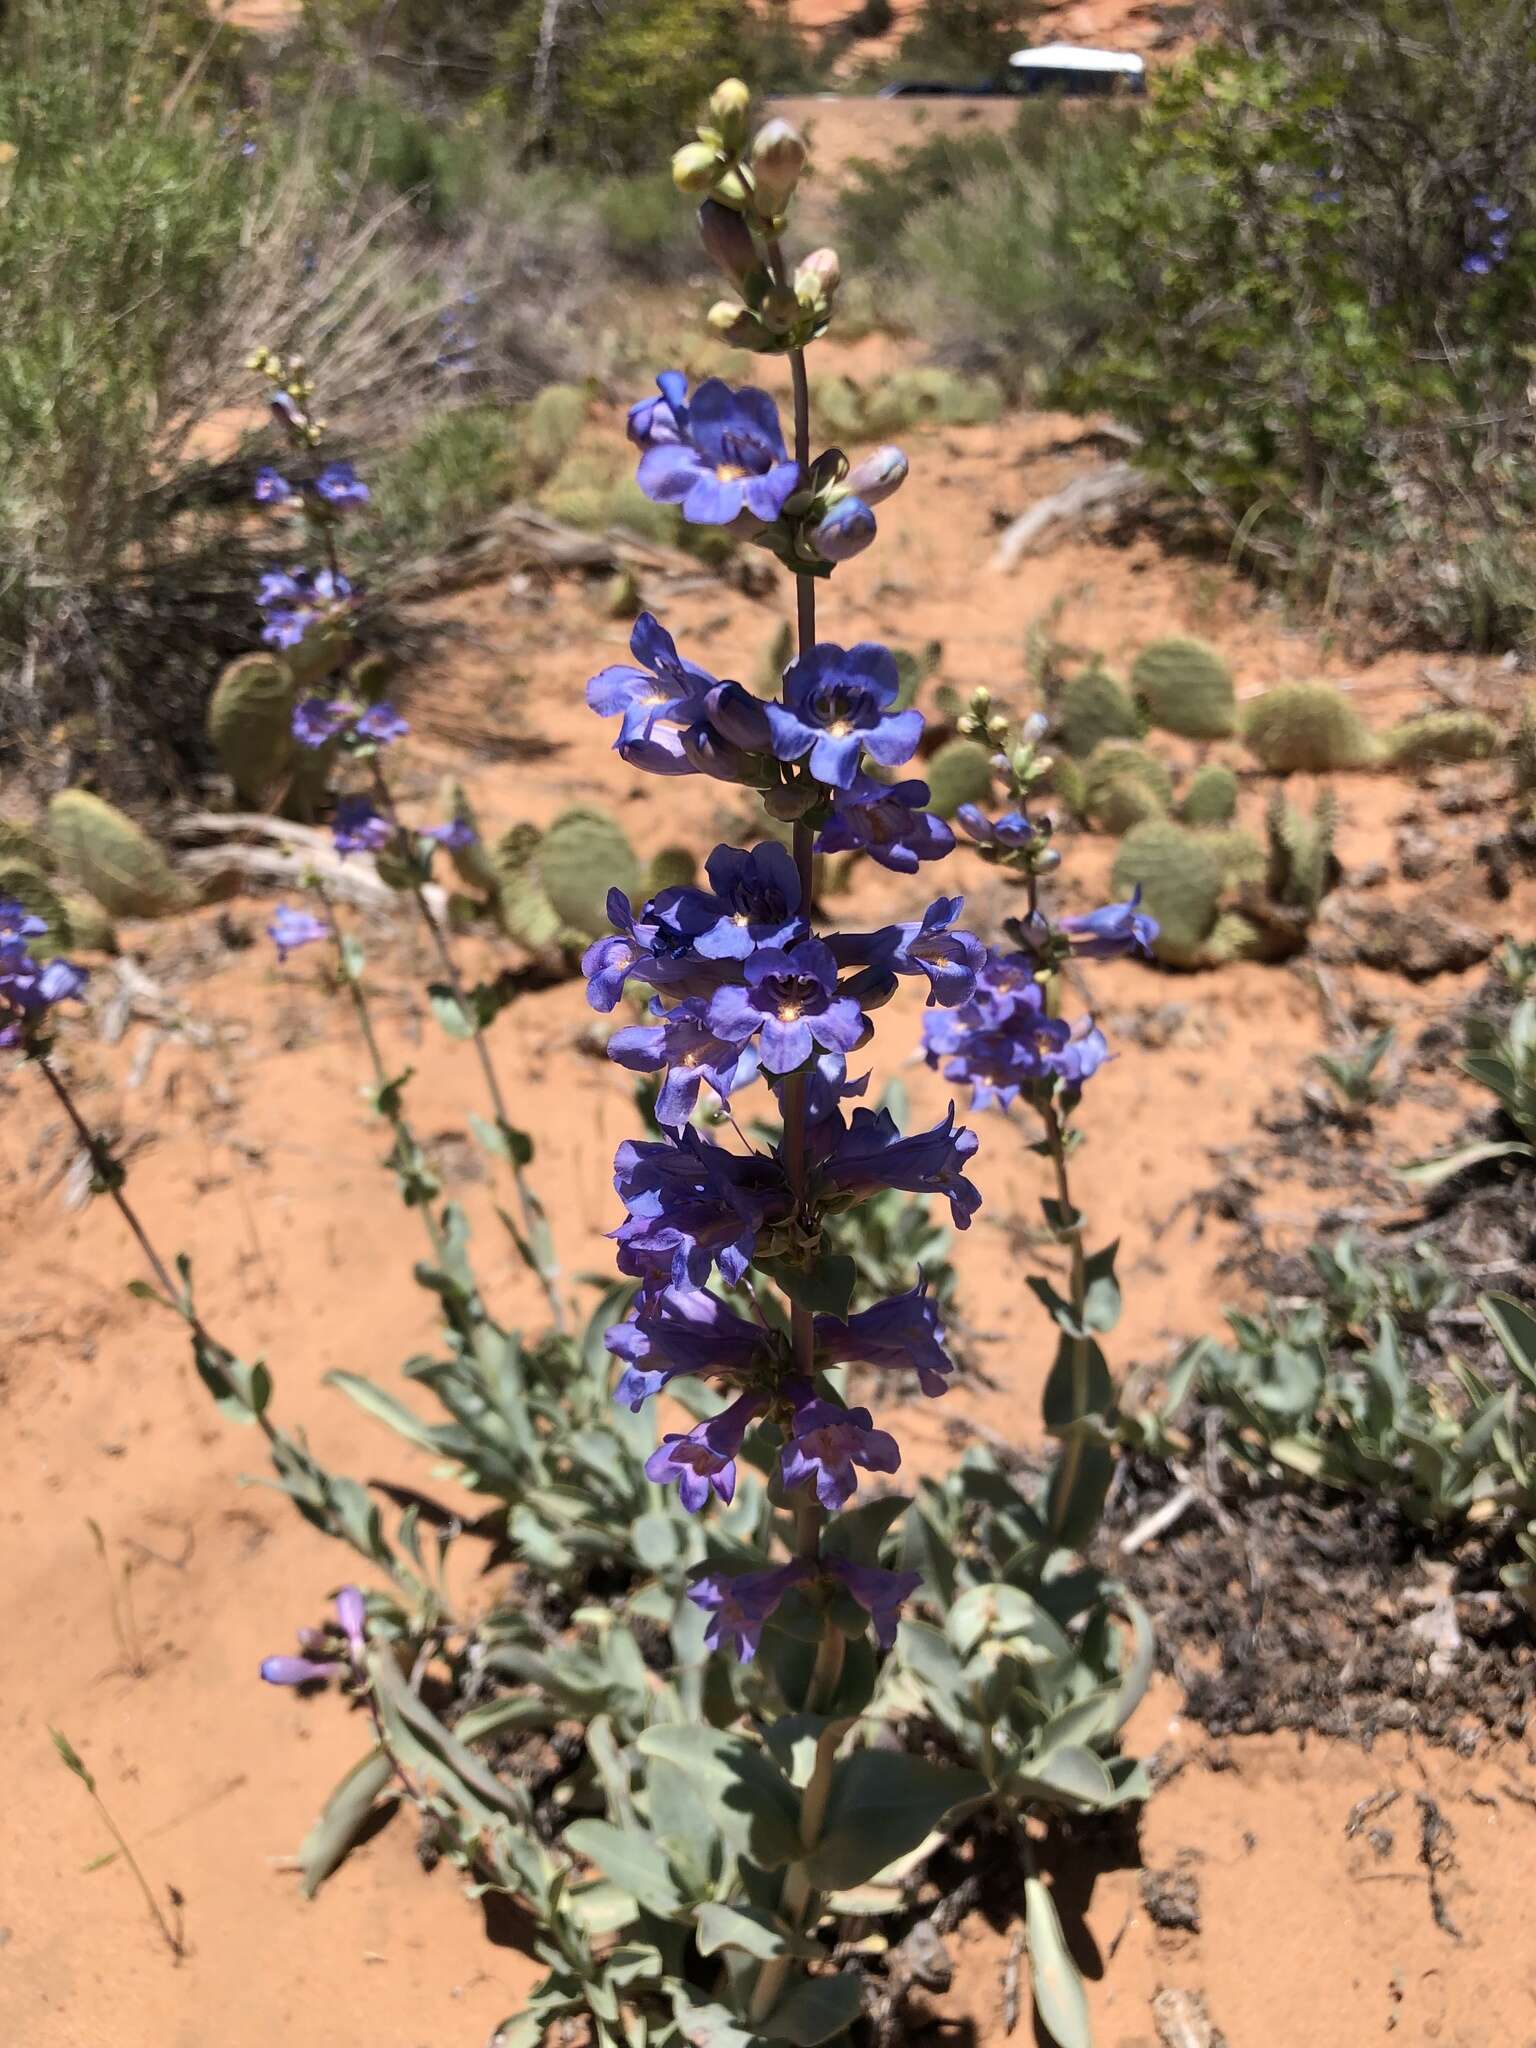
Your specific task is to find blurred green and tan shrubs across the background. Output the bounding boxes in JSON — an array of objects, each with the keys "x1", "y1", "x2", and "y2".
[{"x1": 0, "y1": 0, "x2": 1536, "y2": 797}]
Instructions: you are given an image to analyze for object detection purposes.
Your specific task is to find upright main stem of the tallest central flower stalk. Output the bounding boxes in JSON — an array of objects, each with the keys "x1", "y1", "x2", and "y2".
[{"x1": 752, "y1": 339, "x2": 848, "y2": 2019}]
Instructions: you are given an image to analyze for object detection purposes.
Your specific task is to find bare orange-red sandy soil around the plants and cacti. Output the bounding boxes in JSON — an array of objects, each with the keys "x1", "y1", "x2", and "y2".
[{"x1": 0, "y1": 372, "x2": 1536, "y2": 2048}]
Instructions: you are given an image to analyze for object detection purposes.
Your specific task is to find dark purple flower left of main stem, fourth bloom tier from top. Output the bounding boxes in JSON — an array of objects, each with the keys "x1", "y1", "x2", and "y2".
[{"x1": 610, "y1": 1128, "x2": 791, "y2": 1288}]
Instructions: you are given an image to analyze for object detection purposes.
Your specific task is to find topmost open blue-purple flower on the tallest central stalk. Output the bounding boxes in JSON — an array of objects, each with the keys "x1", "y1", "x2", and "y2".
[{"x1": 629, "y1": 373, "x2": 801, "y2": 526}]
